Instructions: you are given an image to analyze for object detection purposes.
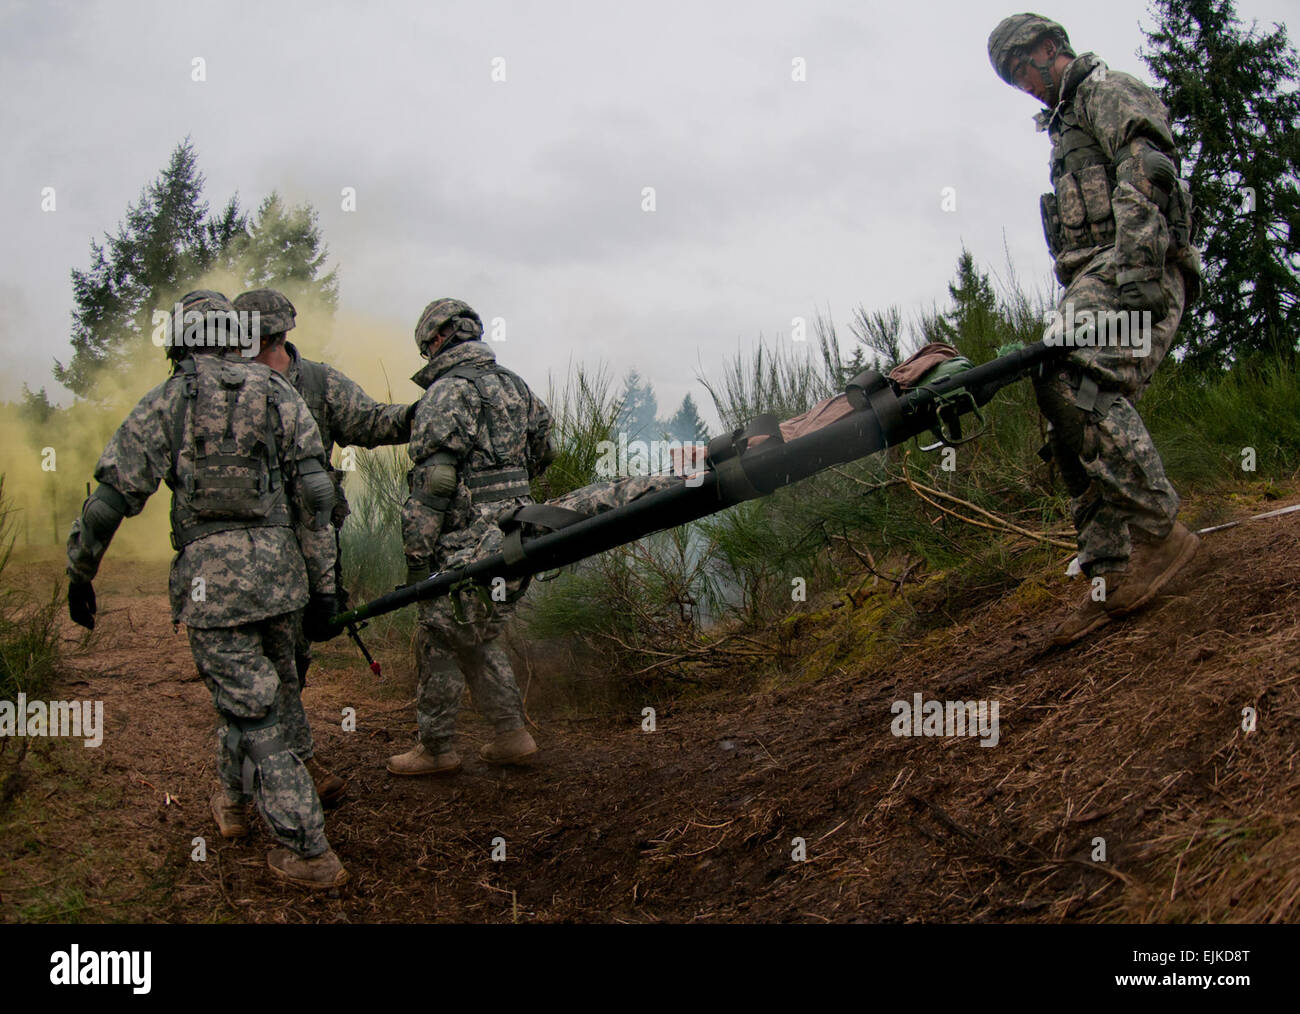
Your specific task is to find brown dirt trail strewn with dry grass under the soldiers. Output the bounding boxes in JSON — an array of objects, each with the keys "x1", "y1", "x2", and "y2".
[{"x1": 0, "y1": 493, "x2": 1300, "y2": 922}]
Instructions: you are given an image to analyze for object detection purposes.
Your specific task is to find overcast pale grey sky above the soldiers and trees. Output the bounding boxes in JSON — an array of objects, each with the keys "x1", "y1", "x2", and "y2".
[{"x1": 0, "y1": 0, "x2": 1294, "y2": 420}]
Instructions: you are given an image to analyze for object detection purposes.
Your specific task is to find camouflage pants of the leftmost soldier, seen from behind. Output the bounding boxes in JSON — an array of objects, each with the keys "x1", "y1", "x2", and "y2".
[{"x1": 186, "y1": 614, "x2": 329, "y2": 857}]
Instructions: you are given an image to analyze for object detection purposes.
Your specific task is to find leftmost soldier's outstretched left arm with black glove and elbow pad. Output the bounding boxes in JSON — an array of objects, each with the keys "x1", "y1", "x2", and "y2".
[{"x1": 68, "y1": 384, "x2": 172, "y2": 631}]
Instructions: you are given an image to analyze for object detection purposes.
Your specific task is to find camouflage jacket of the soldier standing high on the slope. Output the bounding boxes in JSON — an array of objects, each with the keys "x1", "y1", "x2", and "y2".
[{"x1": 1035, "y1": 53, "x2": 1200, "y2": 286}]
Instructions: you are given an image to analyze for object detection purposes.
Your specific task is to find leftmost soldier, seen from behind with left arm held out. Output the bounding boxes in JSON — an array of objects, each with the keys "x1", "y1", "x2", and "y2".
[{"x1": 68, "y1": 290, "x2": 347, "y2": 888}]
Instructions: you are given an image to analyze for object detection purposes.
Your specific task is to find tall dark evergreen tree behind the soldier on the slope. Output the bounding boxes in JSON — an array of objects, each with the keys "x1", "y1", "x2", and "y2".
[{"x1": 1143, "y1": 0, "x2": 1300, "y2": 365}]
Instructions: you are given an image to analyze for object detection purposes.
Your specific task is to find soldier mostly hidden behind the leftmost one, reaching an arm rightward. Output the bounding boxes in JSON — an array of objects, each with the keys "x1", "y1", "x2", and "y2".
[{"x1": 234, "y1": 280, "x2": 415, "y2": 806}]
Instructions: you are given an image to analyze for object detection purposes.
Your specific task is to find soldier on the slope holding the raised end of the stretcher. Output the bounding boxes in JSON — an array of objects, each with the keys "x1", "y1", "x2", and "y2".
[{"x1": 988, "y1": 14, "x2": 1200, "y2": 645}]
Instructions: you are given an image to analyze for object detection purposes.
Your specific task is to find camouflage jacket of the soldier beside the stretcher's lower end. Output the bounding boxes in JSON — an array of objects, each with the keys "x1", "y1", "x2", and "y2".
[{"x1": 402, "y1": 341, "x2": 553, "y2": 573}]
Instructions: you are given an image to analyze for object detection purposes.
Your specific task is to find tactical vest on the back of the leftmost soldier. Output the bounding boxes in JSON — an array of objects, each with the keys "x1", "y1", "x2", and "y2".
[{"x1": 166, "y1": 355, "x2": 291, "y2": 551}]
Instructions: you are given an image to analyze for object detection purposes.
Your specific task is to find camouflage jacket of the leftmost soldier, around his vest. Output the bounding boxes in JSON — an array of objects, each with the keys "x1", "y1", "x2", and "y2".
[{"x1": 68, "y1": 355, "x2": 334, "y2": 628}]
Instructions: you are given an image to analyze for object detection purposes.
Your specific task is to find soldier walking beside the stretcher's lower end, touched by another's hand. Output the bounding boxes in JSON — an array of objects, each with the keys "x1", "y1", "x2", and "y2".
[{"x1": 387, "y1": 299, "x2": 553, "y2": 775}]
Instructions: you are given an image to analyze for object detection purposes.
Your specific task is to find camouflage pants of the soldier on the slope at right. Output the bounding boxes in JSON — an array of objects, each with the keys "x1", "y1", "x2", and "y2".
[{"x1": 1035, "y1": 248, "x2": 1184, "y2": 576}]
